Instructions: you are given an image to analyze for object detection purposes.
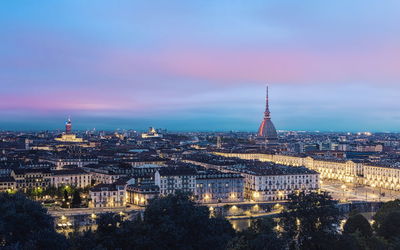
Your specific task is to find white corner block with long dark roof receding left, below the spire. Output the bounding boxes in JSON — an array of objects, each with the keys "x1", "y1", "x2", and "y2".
[{"x1": 184, "y1": 154, "x2": 320, "y2": 202}]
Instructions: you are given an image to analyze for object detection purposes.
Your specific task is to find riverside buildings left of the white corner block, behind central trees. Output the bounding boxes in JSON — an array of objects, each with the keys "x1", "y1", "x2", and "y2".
[{"x1": 89, "y1": 166, "x2": 244, "y2": 207}]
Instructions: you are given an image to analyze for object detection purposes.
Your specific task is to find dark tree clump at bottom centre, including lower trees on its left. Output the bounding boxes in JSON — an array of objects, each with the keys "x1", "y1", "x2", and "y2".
[{"x1": 71, "y1": 193, "x2": 235, "y2": 250}]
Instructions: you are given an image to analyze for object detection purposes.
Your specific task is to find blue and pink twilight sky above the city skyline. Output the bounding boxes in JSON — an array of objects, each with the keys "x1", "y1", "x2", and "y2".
[{"x1": 0, "y1": 0, "x2": 400, "y2": 132}]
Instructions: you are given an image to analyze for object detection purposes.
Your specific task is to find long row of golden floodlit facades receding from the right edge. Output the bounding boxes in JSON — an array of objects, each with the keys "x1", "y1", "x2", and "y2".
[{"x1": 215, "y1": 152, "x2": 400, "y2": 191}]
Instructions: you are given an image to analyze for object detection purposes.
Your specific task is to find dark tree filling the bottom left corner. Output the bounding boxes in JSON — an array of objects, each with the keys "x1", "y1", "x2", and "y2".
[{"x1": 0, "y1": 193, "x2": 68, "y2": 249}]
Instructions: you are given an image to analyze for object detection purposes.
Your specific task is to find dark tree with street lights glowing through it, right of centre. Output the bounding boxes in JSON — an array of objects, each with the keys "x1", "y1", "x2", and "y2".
[{"x1": 279, "y1": 192, "x2": 342, "y2": 249}]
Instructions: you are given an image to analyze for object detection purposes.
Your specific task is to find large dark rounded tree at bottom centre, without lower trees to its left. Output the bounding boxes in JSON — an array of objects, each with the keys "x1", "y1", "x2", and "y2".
[{"x1": 143, "y1": 193, "x2": 235, "y2": 249}]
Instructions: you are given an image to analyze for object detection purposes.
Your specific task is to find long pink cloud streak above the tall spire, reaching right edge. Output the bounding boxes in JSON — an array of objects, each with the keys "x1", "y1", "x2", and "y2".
[{"x1": 150, "y1": 47, "x2": 400, "y2": 83}]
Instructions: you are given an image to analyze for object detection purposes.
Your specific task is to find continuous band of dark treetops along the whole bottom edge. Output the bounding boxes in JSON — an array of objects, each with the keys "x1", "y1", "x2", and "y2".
[{"x1": 5, "y1": 190, "x2": 400, "y2": 250}]
